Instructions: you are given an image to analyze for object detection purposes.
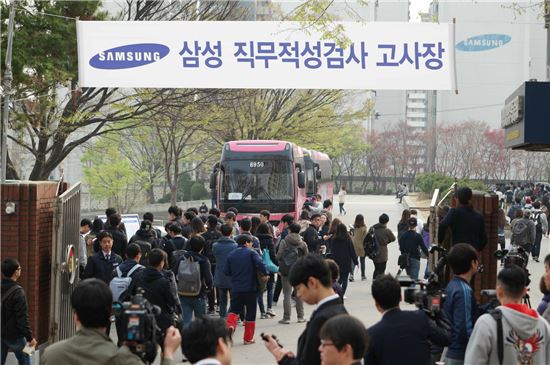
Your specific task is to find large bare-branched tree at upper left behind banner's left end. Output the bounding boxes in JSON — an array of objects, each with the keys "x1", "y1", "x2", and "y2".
[{"x1": 1, "y1": 0, "x2": 239, "y2": 180}]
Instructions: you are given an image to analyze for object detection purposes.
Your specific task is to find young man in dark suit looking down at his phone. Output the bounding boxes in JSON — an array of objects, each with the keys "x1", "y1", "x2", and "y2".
[{"x1": 264, "y1": 254, "x2": 347, "y2": 365}]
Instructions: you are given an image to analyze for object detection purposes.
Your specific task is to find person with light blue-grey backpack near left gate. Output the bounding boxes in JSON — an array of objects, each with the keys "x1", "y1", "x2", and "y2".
[{"x1": 109, "y1": 243, "x2": 145, "y2": 346}]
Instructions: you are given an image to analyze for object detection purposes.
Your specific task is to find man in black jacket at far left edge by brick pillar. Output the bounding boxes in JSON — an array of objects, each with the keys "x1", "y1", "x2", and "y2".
[{"x1": 0, "y1": 258, "x2": 36, "y2": 365}]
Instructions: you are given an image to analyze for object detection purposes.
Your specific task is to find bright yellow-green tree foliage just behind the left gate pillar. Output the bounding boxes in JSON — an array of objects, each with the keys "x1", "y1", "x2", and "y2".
[{"x1": 81, "y1": 139, "x2": 146, "y2": 212}]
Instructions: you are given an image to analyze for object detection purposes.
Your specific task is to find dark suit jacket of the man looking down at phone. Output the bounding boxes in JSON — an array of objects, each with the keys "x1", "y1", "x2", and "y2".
[{"x1": 279, "y1": 298, "x2": 348, "y2": 365}]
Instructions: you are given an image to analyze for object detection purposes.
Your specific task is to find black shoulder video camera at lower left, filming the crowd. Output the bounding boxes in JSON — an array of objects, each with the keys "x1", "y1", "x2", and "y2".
[{"x1": 113, "y1": 288, "x2": 163, "y2": 363}]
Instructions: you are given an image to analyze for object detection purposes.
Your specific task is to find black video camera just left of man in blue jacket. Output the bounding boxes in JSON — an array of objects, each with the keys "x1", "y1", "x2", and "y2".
[{"x1": 397, "y1": 246, "x2": 447, "y2": 318}]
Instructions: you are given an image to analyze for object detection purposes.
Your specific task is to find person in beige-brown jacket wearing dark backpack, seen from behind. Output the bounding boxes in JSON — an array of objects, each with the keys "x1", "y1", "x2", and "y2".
[{"x1": 276, "y1": 223, "x2": 308, "y2": 324}]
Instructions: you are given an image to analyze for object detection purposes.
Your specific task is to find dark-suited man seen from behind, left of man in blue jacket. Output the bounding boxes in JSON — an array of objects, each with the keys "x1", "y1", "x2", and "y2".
[{"x1": 365, "y1": 275, "x2": 451, "y2": 365}]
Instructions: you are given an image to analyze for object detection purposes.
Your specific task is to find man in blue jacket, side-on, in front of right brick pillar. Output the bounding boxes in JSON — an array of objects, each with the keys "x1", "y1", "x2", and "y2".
[{"x1": 443, "y1": 243, "x2": 479, "y2": 365}]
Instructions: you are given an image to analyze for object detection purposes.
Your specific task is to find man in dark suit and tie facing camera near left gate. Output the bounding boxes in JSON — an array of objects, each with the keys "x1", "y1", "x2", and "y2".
[{"x1": 83, "y1": 231, "x2": 122, "y2": 285}]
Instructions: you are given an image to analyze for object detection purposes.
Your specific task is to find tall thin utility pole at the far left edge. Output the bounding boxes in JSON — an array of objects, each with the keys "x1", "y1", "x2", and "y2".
[{"x1": 1, "y1": 0, "x2": 16, "y2": 182}]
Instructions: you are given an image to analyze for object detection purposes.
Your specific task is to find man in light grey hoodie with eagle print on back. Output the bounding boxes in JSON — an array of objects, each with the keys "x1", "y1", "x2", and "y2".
[{"x1": 464, "y1": 266, "x2": 550, "y2": 365}]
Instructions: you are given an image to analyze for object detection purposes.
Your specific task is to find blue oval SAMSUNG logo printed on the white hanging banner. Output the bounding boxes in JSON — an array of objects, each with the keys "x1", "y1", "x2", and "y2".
[{"x1": 90, "y1": 43, "x2": 170, "y2": 70}]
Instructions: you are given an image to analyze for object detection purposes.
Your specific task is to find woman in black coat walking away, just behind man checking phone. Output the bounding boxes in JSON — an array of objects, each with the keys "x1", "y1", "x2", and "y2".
[{"x1": 329, "y1": 223, "x2": 359, "y2": 294}]
